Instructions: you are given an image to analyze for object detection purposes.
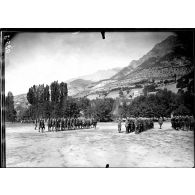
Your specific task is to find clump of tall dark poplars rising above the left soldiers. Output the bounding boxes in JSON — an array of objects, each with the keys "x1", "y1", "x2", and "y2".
[{"x1": 26, "y1": 81, "x2": 68, "y2": 118}]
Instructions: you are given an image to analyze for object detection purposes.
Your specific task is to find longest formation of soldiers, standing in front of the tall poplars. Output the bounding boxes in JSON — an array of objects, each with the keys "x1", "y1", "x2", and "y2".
[{"x1": 35, "y1": 118, "x2": 97, "y2": 132}]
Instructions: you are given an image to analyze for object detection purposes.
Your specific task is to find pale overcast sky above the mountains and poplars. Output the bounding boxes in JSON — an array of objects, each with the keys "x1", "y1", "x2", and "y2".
[{"x1": 5, "y1": 32, "x2": 172, "y2": 95}]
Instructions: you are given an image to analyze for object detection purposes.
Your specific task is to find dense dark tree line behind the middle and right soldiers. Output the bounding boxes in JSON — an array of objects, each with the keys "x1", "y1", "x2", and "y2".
[{"x1": 120, "y1": 89, "x2": 192, "y2": 117}]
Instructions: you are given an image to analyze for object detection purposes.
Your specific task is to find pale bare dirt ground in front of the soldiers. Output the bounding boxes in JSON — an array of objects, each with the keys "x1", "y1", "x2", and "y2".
[{"x1": 6, "y1": 122, "x2": 194, "y2": 167}]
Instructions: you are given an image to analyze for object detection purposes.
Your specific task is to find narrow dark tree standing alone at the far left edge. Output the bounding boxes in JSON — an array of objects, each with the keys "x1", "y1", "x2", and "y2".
[{"x1": 5, "y1": 92, "x2": 16, "y2": 122}]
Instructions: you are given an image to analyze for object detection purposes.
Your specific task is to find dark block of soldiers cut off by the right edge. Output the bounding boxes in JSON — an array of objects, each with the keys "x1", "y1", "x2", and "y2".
[{"x1": 171, "y1": 115, "x2": 195, "y2": 131}]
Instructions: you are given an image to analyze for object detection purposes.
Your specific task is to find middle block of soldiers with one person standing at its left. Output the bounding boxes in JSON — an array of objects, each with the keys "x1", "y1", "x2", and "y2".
[{"x1": 118, "y1": 117, "x2": 154, "y2": 134}]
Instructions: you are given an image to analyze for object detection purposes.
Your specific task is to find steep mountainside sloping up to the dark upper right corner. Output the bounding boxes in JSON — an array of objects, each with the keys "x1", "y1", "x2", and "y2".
[{"x1": 79, "y1": 35, "x2": 194, "y2": 97}]
